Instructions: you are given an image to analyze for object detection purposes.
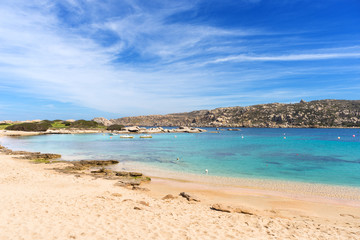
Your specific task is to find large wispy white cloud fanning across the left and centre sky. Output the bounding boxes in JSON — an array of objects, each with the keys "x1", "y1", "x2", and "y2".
[{"x1": 0, "y1": 0, "x2": 360, "y2": 118}]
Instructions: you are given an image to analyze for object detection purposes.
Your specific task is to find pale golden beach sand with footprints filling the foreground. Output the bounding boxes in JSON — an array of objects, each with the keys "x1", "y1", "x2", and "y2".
[{"x1": 0, "y1": 155, "x2": 360, "y2": 239}]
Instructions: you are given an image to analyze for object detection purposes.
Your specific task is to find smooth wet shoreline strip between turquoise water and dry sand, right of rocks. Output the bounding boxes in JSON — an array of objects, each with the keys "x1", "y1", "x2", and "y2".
[{"x1": 114, "y1": 162, "x2": 360, "y2": 207}]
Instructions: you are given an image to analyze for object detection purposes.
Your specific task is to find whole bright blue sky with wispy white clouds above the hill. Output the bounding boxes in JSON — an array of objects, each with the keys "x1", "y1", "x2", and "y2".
[{"x1": 0, "y1": 0, "x2": 360, "y2": 120}]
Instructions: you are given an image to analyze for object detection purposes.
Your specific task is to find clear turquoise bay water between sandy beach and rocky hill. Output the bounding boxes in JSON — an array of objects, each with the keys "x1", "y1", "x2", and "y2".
[{"x1": 0, "y1": 128, "x2": 360, "y2": 187}]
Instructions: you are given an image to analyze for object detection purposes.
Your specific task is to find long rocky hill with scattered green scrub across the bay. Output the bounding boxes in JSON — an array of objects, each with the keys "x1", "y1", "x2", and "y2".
[{"x1": 94, "y1": 100, "x2": 360, "y2": 128}]
